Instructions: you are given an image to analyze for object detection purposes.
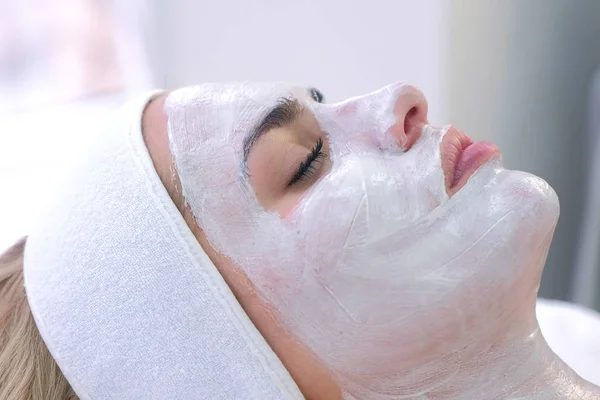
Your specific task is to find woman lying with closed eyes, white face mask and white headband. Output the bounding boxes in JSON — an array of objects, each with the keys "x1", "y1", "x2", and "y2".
[{"x1": 0, "y1": 83, "x2": 600, "y2": 400}]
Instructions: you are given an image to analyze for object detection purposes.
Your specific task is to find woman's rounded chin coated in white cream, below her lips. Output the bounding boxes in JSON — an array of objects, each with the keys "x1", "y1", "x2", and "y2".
[{"x1": 443, "y1": 165, "x2": 559, "y2": 290}]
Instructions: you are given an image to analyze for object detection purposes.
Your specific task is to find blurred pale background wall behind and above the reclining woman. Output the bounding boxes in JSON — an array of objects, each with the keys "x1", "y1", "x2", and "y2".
[{"x1": 0, "y1": 0, "x2": 600, "y2": 309}]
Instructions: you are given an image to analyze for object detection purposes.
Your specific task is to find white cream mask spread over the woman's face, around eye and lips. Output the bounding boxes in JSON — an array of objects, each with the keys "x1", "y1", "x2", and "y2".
[{"x1": 165, "y1": 83, "x2": 558, "y2": 399}]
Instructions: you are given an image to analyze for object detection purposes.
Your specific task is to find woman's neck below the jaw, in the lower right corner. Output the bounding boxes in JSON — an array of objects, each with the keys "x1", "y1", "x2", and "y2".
[{"x1": 429, "y1": 325, "x2": 600, "y2": 400}]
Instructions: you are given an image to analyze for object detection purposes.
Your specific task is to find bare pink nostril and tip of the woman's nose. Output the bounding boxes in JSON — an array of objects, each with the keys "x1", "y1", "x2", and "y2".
[{"x1": 387, "y1": 85, "x2": 428, "y2": 151}]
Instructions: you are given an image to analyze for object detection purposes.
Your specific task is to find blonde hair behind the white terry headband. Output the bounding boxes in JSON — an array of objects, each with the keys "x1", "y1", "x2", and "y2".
[{"x1": 0, "y1": 238, "x2": 78, "y2": 400}]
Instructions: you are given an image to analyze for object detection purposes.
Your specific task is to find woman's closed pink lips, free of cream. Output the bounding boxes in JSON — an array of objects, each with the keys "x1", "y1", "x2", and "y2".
[{"x1": 441, "y1": 126, "x2": 500, "y2": 196}]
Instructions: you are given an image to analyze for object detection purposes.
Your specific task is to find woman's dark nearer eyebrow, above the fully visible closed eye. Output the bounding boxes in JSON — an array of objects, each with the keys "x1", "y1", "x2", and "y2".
[{"x1": 244, "y1": 97, "x2": 304, "y2": 164}]
